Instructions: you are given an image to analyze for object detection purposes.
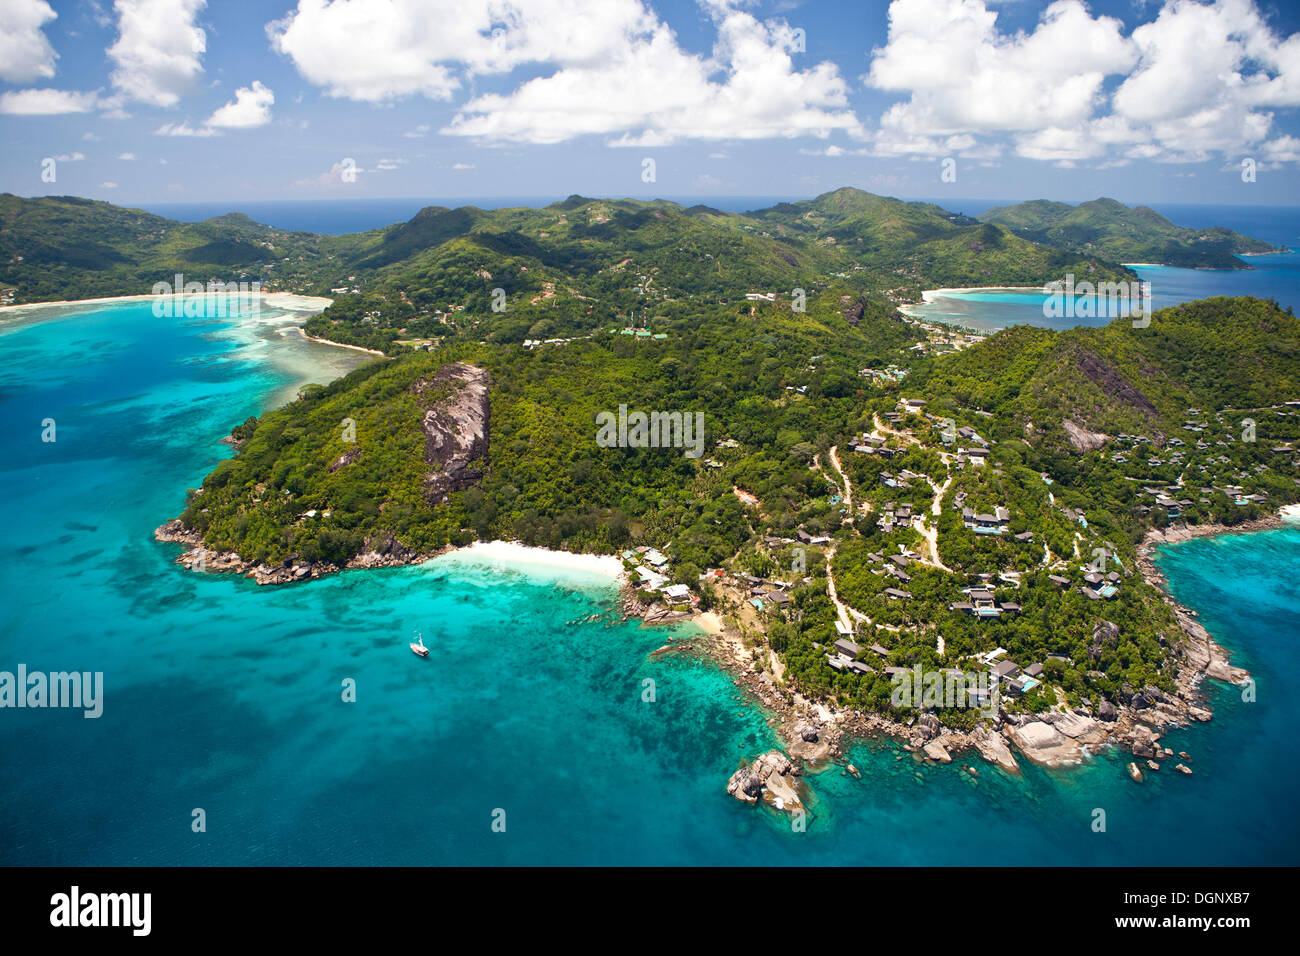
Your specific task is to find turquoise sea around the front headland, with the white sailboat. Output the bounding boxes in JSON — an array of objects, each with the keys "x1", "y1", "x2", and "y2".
[{"x1": 0, "y1": 304, "x2": 1300, "y2": 865}]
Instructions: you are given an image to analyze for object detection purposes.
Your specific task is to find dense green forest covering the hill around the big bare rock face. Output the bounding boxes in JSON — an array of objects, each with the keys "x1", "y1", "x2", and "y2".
[{"x1": 186, "y1": 295, "x2": 917, "y2": 568}]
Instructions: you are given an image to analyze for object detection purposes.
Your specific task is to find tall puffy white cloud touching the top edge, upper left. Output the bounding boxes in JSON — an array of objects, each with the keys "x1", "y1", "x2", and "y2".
[{"x1": 108, "y1": 0, "x2": 207, "y2": 107}]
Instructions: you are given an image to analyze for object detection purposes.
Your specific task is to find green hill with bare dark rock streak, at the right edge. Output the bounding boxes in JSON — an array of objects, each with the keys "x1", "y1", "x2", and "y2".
[{"x1": 915, "y1": 297, "x2": 1300, "y2": 450}]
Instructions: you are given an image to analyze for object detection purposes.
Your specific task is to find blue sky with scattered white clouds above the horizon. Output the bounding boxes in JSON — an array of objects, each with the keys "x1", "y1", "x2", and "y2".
[{"x1": 0, "y1": 0, "x2": 1300, "y2": 206}]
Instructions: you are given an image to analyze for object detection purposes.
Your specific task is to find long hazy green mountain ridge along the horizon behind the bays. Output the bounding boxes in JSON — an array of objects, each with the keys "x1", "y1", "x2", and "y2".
[{"x1": 0, "y1": 189, "x2": 1131, "y2": 308}]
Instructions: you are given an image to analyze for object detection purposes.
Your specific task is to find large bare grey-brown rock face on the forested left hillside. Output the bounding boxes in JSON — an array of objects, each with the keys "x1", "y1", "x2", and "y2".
[{"x1": 411, "y1": 362, "x2": 491, "y2": 503}]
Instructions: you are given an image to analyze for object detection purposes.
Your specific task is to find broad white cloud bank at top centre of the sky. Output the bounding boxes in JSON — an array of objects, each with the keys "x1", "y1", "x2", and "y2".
[{"x1": 267, "y1": 0, "x2": 859, "y2": 146}]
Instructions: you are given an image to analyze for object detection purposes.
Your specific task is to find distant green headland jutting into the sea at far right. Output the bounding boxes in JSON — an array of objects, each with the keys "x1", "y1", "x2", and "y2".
[{"x1": 979, "y1": 199, "x2": 1277, "y2": 269}]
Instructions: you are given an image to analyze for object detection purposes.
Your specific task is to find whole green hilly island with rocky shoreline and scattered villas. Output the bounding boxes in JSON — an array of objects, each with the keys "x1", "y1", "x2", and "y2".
[{"x1": 0, "y1": 189, "x2": 1300, "y2": 812}]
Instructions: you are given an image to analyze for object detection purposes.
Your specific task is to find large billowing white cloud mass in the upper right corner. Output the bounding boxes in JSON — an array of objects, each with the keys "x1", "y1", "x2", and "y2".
[{"x1": 867, "y1": 0, "x2": 1300, "y2": 165}]
